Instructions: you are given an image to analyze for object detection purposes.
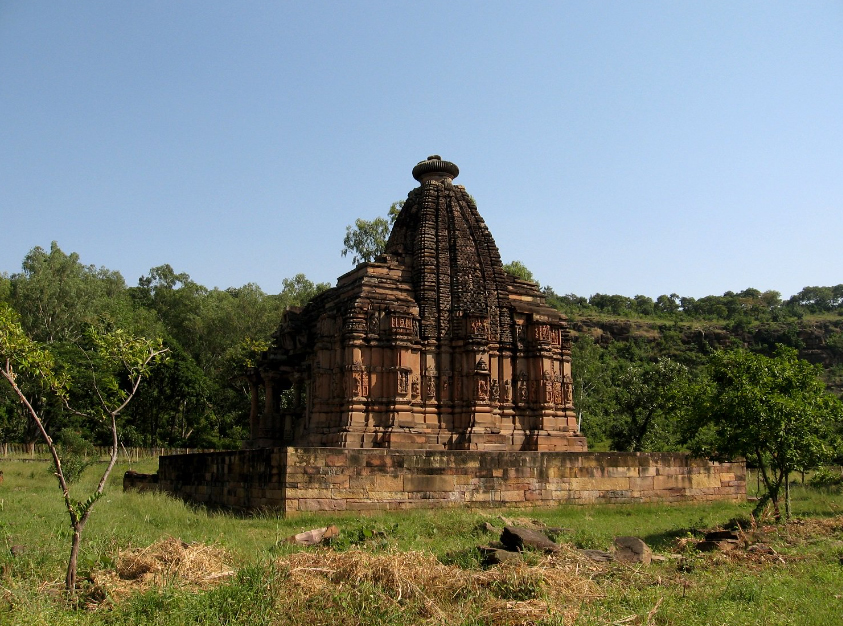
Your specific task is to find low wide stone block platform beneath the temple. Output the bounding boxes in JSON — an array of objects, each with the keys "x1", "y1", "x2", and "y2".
[{"x1": 158, "y1": 447, "x2": 746, "y2": 515}]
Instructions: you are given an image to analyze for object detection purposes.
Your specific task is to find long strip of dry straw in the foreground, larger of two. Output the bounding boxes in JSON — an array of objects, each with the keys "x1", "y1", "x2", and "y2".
[{"x1": 277, "y1": 549, "x2": 602, "y2": 624}]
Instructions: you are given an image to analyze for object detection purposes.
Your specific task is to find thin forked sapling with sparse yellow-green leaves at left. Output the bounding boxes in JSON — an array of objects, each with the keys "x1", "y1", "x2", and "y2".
[{"x1": 0, "y1": 304, "x2": 166, "y2": 594}]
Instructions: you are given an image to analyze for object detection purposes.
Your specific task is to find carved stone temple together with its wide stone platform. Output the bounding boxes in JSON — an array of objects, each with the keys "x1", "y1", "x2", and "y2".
[{"x1": 150, "y1": 156, "x2": 746, "y2": 515}]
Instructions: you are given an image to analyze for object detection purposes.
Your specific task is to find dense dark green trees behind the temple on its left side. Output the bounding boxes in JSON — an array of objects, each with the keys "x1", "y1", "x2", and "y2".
[{"x1": 0, "y1": 243, "x2": 328, "y2": 448}]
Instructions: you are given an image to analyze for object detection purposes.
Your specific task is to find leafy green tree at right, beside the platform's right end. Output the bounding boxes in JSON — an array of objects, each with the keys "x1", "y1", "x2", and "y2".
[{"x1": 691, "y1": 346, "x2": 843, "y2": 519}]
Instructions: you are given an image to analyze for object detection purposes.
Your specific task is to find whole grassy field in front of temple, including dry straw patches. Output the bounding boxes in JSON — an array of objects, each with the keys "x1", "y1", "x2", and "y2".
[{"x1": 0, "y1": 454, "x2": 843, "y2": 626}]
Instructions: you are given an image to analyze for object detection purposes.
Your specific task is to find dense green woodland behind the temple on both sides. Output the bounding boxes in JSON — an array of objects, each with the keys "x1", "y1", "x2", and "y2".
[{"x1": 0, "y1": 239, "x2": 843, "y2": 455}]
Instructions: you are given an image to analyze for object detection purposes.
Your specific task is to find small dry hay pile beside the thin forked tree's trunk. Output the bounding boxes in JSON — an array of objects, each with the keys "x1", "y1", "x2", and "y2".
[{"x1": 89, "y1": 537, "x2": 234, "y2": 603}]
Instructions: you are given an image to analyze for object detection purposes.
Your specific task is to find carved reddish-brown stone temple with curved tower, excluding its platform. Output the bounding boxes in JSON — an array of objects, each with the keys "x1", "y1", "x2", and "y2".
[{"x1": 244, "y1": 155, "x2": 586, "y2": 452}]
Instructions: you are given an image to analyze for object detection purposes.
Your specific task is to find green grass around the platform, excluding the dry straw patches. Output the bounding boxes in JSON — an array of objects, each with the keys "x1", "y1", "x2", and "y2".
[{"x1": 0, "y1": 454, "x2": 843, "y2": 626}]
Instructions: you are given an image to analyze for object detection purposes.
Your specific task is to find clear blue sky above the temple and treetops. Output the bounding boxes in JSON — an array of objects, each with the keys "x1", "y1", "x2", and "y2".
[{"x1": 0, "y1": 0, "x2": 843, "y2": 297}]
